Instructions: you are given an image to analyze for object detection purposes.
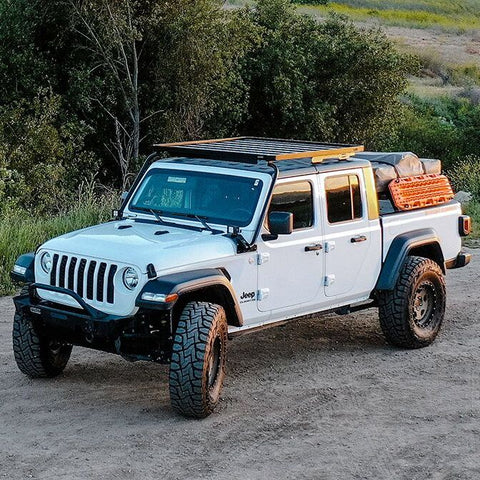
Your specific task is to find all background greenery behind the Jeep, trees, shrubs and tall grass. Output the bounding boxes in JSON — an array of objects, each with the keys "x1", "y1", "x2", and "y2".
[{"x1": 0, "y1": 0, "x2": 480, "y2": 294}]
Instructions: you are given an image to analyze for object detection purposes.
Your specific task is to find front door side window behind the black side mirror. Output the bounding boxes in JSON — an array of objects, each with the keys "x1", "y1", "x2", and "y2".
[{"x1": 269, "y1": 182, "x2": 313, "y2": 230}]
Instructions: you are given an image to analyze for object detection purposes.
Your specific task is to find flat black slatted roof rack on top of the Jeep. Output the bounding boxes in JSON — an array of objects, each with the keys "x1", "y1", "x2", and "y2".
[{"x1": 155, "y1": 137, "x2": 364, "y2": 164}]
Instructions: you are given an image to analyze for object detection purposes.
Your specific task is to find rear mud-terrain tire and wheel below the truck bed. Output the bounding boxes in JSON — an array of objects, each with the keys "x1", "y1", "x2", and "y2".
[{"x1": 378, "y1": 256, "x2": 446, "y2": 348}]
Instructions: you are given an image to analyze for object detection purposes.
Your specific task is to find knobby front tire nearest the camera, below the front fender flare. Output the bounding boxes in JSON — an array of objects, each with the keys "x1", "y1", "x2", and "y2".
[{"x1": 170, "y1": 302, "x2": 228, "y2": 418}]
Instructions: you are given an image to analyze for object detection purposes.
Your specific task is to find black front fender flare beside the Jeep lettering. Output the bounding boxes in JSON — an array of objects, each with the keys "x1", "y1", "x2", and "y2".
[{"x1": 136, "y1": 268, "x2": 243, "y2": 327}]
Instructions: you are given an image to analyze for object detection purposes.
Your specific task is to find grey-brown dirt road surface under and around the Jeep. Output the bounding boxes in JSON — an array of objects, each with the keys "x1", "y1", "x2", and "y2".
[{"x1": 0, "y1": 250, "x2": 480, "y2": 480}]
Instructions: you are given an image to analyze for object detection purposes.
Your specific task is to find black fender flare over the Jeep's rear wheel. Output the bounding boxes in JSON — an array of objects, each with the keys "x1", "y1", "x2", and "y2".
[{"x1": 375, "y1": 228, "x2": 445, "y2": 290}]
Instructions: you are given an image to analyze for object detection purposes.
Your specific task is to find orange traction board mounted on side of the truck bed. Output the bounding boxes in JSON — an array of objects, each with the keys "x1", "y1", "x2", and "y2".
[{"x1": 388, "y1": 174, "x2": 453, "y2": 210}]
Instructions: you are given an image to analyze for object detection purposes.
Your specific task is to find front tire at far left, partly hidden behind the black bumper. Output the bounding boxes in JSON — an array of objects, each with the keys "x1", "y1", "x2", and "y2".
[{"x1": 12, "y1": 290, "x2": 72, "y2": 378}]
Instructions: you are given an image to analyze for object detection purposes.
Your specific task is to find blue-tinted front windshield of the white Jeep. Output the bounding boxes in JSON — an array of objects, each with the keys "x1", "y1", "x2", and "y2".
[{"x1": 129, "y1": 168, "x2": 263, "y2": 227}]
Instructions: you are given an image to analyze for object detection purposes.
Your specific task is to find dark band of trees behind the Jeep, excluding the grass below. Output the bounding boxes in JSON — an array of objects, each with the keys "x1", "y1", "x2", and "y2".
[{"x1": 0, "y1": 0, "x2": 416, "y2": 205}]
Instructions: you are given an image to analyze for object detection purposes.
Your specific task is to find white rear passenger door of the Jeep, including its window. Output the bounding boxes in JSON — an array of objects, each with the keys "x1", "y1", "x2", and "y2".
[{"x1": 320, "y1": 169, "x2": 382, "y2": 299}]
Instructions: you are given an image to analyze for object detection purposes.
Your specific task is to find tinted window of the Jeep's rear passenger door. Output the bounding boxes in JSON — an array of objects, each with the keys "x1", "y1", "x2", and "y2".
[{"x1": 325, "y1": 175, "x2": 363, "y2": 223}]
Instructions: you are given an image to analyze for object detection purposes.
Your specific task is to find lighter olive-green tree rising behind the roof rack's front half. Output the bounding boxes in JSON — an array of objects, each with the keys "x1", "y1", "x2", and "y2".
[{"x1": 147, "y1": 0, "x2": 258, "y2": 140}]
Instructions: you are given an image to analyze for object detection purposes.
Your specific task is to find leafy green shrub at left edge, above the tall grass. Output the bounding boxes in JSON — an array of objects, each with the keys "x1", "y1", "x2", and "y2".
[{"x1": 0, "y1": 90, "x2": 96, "y2": 213}]
